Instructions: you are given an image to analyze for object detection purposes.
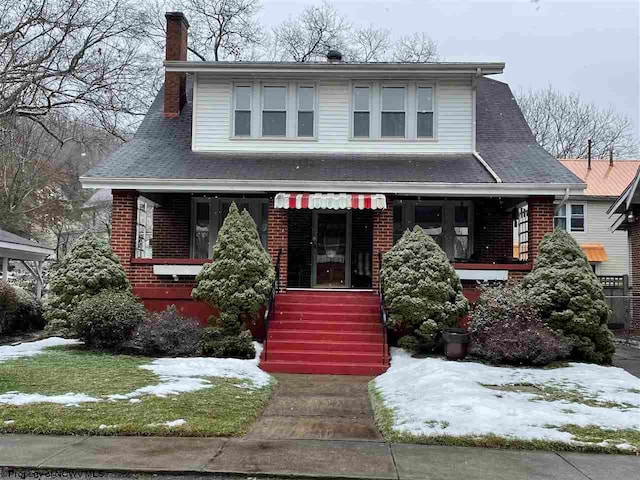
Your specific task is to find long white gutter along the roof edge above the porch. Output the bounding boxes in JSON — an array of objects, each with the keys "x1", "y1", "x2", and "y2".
[{"x1": 80, "y1": 177, "x2": 584, "y2": 197}]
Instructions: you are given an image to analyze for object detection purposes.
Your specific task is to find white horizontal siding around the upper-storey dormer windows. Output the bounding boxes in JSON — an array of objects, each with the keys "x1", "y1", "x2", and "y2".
[{"x1": 193, "y1": 76, "x2": 473, "y2": 153}]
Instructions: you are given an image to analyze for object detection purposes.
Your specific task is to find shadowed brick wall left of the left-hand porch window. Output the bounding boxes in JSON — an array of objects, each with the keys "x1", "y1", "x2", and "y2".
[{"x1": 152, "y1": 193, "x2": 191, "y2": 258}]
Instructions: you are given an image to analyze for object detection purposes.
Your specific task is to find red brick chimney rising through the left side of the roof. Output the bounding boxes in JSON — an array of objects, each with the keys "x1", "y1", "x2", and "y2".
[{"x1": 164, "y1": 12, "x2": 189, "y2": 118}]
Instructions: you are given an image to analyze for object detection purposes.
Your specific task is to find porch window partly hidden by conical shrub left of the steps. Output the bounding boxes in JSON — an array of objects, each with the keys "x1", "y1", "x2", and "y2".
[{"x1": 191, "y1": 197, "x2": 269, "y2": 258}]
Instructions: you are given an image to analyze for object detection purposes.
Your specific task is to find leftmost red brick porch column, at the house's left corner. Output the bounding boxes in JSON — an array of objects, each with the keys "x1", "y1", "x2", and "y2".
[{"x1": 111, "y1": 190, "x2": 138, "y2": 275}]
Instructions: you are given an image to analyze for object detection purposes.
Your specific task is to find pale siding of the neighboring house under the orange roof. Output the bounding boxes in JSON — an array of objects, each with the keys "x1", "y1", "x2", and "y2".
[{"x1": 571, "y1": 200, "x2": 629, "y2": 275}]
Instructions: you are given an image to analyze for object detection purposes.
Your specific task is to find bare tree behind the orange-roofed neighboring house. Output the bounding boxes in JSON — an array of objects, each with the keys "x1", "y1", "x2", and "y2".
[{"x1": 516, "y1": 87, "x2": 639, "y2": 158}]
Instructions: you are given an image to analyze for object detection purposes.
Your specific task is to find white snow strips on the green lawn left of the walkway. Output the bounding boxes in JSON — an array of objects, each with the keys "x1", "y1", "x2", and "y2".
[{"x1": 0, "y1": 337, "x2": 271, "y2": 406}]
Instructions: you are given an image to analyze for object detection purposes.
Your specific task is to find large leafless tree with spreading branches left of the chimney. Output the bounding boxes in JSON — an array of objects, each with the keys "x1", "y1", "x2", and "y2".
[{"x1": 0, "y1": 0, "x2": 157, "y2": 143}]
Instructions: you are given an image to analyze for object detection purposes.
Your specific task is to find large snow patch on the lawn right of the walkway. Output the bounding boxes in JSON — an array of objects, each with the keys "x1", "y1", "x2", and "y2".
[{"x1": 375, "y1": 349, "x2": 640, "y2": 447}]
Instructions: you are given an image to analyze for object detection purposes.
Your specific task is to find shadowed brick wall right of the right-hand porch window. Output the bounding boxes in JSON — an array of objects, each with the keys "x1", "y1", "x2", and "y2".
[{"x1": 473, "y1": 199, "x2": 513, "y2": 263}]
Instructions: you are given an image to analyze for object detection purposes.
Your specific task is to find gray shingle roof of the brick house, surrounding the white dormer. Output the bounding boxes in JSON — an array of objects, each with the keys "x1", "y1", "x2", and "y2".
[{"x1": 86, "y1": 79, "x2": 580, "y2": 187}]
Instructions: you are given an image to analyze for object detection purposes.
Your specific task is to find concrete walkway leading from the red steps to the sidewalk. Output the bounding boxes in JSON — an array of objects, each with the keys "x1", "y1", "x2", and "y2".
[{"x1": 245, "y1": 374, "x2": 382, "y2": 441}]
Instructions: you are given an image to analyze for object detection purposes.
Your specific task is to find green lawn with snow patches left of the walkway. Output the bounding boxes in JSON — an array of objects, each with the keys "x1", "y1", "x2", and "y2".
[{"x1": 0, "y1": 338, "x2": 272, "y2": 434}]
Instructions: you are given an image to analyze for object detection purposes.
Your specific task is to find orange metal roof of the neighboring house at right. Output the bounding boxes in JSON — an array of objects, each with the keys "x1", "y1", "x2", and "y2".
[{"x1": 560, "y1": 159, "x2": 640, "y2": 197}]
